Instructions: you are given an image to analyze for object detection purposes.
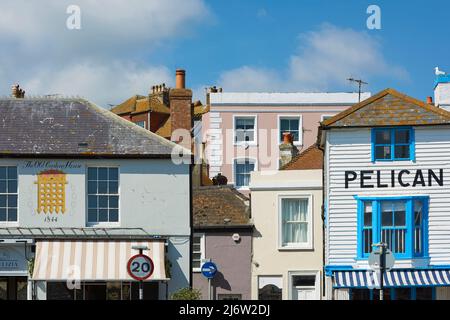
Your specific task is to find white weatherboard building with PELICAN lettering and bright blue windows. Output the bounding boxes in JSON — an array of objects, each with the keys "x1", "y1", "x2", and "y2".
[{"x1": 319, "y1": 89, "x2": 450, "y2": 300}]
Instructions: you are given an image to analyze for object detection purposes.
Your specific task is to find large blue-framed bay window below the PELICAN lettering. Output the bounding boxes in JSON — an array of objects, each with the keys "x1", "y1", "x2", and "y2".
[{"x1": 358, "y1": 197, "x2": 428, "y2": 258}]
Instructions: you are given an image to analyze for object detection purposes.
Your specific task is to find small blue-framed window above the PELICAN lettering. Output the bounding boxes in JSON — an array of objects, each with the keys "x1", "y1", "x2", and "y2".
[{"x1": 372, "y1": 128, "x2": 415, "y2": 161}]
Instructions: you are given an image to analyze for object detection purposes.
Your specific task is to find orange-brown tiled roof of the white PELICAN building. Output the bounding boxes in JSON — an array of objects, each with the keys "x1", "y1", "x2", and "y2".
[{"x1": 321, "y1": 88, "x2": 450, "y2": 129}]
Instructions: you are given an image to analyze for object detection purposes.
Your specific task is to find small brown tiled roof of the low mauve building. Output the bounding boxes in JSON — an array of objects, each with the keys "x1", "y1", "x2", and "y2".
[{"x1": 193, "y1": 186, "x2": 252, "y2": 228}]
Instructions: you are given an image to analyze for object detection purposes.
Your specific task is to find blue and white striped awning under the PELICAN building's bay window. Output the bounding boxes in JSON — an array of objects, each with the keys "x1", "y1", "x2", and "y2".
[{"x1": 333, "y1": 270, "x2": 450, "y2": 289}]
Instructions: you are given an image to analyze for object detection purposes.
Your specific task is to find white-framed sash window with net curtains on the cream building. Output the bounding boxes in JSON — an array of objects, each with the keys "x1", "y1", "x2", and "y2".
[{"x1": 280, "y1": 197, "x2": 312, "y2": 248}]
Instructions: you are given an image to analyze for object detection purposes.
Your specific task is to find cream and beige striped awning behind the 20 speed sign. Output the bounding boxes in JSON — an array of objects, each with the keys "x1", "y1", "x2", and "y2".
[{"x1": 32, "y1": 240, "x2": 168, "y2": 281}]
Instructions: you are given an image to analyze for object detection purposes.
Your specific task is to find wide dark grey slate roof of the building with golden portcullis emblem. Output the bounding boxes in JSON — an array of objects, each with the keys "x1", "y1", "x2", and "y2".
[{"x1": 0, "y1": 98, "x2": 189, "y2": 158}]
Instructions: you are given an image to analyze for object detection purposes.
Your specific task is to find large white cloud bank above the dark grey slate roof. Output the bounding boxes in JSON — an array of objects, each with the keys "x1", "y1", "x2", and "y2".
[{"x1": 0, "y1": 0, "x2": 211, "y2": 106}]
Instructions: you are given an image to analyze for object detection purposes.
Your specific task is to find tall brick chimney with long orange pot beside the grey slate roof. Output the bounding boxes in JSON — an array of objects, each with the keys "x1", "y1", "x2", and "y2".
[{"x1": 169, "y1": 69, "x2": 193, "y2": 142}]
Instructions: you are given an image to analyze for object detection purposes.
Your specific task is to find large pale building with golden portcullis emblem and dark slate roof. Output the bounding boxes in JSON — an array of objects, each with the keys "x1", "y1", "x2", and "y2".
[{"x1": 0, "y1": 98, "x2": 190, "y2": 300}]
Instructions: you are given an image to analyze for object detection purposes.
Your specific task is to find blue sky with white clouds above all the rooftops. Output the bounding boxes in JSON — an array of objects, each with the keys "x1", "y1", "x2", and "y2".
[{"x1": 0, "y1": 0, "x2": 450, "y2": 106}]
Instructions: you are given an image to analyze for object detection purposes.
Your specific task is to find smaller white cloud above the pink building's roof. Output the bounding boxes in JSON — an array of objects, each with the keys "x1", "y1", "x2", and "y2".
[{"x1": 218, "y1": 24, "x2": 408, "y2": 91}]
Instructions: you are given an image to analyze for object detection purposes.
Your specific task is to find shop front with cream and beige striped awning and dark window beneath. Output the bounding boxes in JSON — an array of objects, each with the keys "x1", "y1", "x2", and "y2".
[{"x1": 31, "y1": 239, "x2": 170, "y2": 300}]
